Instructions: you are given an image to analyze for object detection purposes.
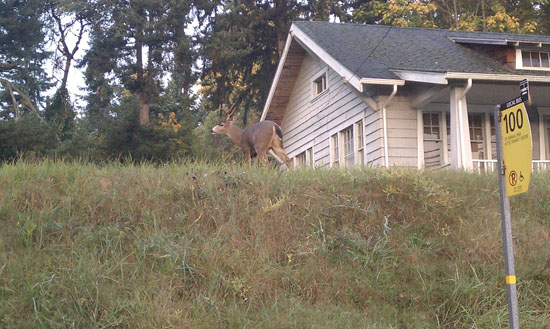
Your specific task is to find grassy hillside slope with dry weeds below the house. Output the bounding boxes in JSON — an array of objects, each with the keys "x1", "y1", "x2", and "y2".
[{"x1": 0, "y1": 162, "x2": 550, "y2": 328}]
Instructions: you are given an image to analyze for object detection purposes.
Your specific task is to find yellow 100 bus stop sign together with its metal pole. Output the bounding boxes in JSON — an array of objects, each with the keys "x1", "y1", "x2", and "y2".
[{"x1": 494, "y1": 80, "x2": 533, "y2": 329}]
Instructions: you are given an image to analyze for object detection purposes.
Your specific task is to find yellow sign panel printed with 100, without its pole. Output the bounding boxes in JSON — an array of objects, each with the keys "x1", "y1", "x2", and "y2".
[{"x1": 500, "y1": 102, "x2": 533, "y2": 196}]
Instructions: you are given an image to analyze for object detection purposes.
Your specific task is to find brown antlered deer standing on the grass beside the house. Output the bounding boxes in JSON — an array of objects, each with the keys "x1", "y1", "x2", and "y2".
[{"x1": 212, "y1": 104, "x2": 290, "y2": 168}]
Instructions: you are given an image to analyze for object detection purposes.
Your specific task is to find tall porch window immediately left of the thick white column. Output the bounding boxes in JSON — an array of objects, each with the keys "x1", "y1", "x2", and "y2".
[{"x1": 422, "y1": 113, "x2": 443, "y2": 168}]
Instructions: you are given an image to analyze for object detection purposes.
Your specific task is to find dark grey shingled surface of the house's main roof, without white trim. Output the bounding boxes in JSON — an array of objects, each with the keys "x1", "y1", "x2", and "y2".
[{"x1": 294, "y1": 22, "x2": 550, "y2": 79}]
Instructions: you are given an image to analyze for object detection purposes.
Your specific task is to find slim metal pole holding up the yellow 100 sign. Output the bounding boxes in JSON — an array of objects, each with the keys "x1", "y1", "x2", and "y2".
[{"x1": 494, "y1": 105, "x2": 519, "y2": 329}]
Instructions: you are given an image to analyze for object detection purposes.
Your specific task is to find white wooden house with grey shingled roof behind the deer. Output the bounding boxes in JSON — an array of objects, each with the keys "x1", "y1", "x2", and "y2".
[{"x1": 261, "y1": 22, "x2": 550, "y2": 170}]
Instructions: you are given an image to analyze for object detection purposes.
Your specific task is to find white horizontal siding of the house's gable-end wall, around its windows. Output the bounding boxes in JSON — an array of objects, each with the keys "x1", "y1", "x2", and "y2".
[{"x1": 281, "y1": 55, "x2": 382, "y2": 167}]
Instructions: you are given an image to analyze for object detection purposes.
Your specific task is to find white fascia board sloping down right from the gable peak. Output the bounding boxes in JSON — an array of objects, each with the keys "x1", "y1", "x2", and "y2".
[{"x1": 290, "y1": 24, "x2": 361, "y2": 90}]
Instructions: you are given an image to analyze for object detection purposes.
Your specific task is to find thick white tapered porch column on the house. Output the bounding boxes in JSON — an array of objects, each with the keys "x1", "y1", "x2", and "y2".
[{"x1": 450, "y1": 86, "x2": 473, "y2": 170}]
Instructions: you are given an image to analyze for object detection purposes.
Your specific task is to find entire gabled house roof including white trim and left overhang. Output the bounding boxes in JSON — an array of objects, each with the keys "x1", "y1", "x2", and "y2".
[{"x1": 261, "y1": 22, "x2": 550, "y2": 124}]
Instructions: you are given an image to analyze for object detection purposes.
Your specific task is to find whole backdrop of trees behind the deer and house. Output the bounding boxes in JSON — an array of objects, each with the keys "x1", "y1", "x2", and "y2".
[{"x1": 0, "y1": 0, "x2": 550, "y2": 162}]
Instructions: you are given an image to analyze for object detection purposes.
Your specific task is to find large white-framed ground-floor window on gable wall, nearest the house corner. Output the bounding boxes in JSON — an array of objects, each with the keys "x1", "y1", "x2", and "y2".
[{"x1": 330, "y1": 120, "x2": 365, "y2": 168}]
